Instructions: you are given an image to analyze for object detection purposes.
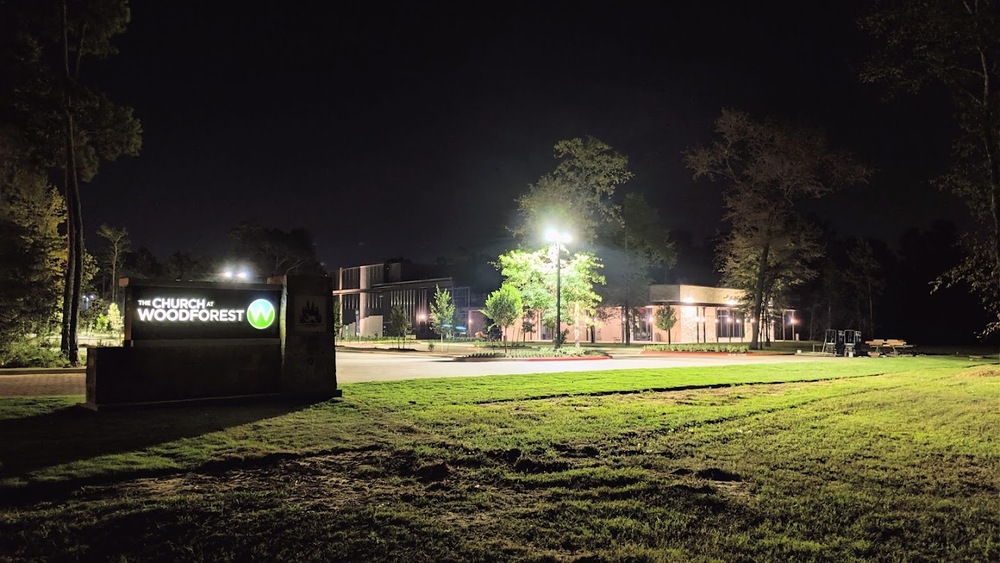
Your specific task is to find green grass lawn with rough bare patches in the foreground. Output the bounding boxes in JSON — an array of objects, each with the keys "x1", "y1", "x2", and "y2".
[{"x1": 0, "y1": 357, "x2": 1000, "y2": 562}]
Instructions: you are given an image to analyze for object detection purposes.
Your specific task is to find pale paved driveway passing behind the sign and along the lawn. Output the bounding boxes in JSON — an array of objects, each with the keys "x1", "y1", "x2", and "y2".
[{"x1": 0, "y1": 350, "x2": 837, "y2": 397}]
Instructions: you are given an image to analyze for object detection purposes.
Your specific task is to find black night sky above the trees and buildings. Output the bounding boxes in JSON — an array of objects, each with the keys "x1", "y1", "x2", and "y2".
[{"x1": 83, "y1": 0, "x2": 964, "y2": 274}]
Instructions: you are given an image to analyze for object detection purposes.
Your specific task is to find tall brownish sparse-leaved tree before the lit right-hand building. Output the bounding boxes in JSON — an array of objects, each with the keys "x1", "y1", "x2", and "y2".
[{"x1": 685, "y1": 109, "x2": 871, "y2": 349}]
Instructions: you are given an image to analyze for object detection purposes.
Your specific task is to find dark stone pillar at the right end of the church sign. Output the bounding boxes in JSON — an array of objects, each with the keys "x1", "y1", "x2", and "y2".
[{"x1": 268, "y1": 276, "x2": 341, "y2": 397}]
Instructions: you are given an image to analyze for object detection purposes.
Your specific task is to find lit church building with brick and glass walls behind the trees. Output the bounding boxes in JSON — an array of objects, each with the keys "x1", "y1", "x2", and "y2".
[{"x1": 333, "y1": 261, "x2": 796, "y2": 344}]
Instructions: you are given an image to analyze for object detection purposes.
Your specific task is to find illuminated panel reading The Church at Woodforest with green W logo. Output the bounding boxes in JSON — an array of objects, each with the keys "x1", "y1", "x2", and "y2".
[{"x1": 126, "y1": 284, "x2": 281, "y2": 341}]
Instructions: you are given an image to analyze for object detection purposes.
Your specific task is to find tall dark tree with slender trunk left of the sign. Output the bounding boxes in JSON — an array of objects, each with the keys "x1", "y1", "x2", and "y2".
[{"x1": 0, "y1": 0, "x2": 142, "y2": 363}]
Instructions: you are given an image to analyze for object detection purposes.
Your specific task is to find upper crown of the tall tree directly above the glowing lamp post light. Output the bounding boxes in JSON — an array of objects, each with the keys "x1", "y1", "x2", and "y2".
[{"x1": 515, "y1": 137, "x2": 632, "y2": 243}]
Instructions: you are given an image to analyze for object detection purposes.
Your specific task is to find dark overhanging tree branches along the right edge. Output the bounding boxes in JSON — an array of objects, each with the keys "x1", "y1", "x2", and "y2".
[{"x1": 861, "y1": 0, "x2": 1000, "y2": 333}]
